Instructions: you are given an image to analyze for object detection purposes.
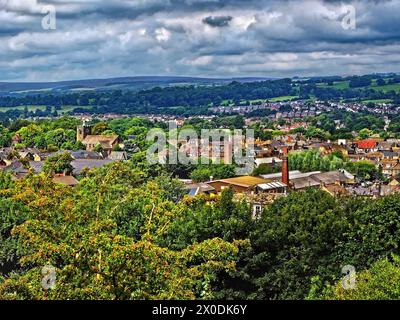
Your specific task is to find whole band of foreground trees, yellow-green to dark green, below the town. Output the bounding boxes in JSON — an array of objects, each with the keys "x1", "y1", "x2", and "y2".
[{"x1": 0, "y1": 160, "x2": 400, "y2": 300}]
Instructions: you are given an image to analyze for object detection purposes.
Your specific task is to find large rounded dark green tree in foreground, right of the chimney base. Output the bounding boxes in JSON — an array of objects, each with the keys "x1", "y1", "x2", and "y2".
[{"x1": 249, "y1": 190, "x2": 349, "y2": 299}]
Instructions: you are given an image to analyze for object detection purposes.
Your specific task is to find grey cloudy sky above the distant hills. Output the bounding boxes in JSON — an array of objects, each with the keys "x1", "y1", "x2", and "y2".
[{"x1": 0, "y1": 0, "x2": 400, "y2": 81}]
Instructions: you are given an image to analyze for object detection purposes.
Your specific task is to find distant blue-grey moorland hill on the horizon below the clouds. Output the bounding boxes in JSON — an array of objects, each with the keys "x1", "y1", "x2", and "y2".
[{"x1": 0, "y1": 76, "x2": 273, "y2": 95}]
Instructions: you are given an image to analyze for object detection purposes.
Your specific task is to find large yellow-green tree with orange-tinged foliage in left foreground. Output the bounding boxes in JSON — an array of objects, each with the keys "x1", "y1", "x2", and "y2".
[{"x1": 0, "y1": 163, "x2": 239, "y2": 299}]
